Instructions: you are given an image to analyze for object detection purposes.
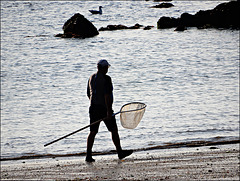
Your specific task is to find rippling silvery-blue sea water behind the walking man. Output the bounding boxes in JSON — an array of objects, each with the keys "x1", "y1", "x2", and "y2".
[{"x1": 1, "y1": 1, "x2": 239, "y2": 158}]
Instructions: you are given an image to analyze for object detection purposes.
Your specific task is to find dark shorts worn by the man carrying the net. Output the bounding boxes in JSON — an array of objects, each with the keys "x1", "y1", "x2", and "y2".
[{"x1": 89, "y1": 105, "x2": 118, "y2": 132}]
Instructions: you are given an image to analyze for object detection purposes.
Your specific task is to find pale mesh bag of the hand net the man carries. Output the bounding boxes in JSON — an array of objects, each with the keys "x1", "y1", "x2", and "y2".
[{"x1": 120, "y1": 102, "x2": 146, "y2": 129}]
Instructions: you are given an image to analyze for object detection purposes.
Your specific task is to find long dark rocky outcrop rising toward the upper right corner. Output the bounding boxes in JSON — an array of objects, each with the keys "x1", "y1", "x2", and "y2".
[{"x1": 157, "y1": 0, "x2": 240, "y2": 29}]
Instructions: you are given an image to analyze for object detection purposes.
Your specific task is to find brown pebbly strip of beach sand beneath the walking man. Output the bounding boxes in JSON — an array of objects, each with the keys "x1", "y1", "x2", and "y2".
[{"x1": 1, "y1": 144, "x2": 239, "y2": 180}]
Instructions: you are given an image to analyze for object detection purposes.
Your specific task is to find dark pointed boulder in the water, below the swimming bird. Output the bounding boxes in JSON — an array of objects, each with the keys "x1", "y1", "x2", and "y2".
[{"x1": 55, "y1": 13, "x2": 99, "y2": 38}]
